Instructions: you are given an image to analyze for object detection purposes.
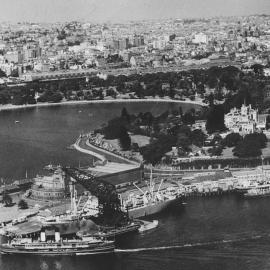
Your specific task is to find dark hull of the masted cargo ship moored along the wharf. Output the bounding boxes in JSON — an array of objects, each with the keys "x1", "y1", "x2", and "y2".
[{"x1": 128, "y1": 198, "x2": 181, "y2": 218}]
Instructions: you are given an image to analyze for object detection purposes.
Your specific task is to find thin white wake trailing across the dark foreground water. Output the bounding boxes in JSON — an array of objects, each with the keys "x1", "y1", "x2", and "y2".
[{"x1": 115, "y1": 235, "x2": 270, "y2": 253}]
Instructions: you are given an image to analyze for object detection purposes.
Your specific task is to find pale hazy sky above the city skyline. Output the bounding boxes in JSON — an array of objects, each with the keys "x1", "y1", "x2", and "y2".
[{"x1": 0, "y1": 0, "x2": 270, "y2": 22}]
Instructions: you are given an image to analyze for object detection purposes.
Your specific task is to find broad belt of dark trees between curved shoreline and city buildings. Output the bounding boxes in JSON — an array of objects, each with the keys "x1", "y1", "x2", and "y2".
[{"x1": 0, "y1": 66, "x2": 269, "y2": 113}]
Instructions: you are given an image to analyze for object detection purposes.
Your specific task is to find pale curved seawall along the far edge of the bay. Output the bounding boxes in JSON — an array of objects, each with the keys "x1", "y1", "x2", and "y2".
[{"x1": 0, "y1": 98, "x2": 208, "y2": 112}]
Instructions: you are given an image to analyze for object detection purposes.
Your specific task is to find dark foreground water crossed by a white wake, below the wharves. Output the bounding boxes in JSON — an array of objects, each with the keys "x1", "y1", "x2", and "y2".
[{"x1": 0, "y1": 195, "x2": 270, "y2": 270}]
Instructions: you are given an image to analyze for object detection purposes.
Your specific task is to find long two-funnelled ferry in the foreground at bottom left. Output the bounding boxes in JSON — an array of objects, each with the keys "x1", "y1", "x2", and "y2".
[{"x1": 0, "y1": 232, "x2": 115, "y2": 256}]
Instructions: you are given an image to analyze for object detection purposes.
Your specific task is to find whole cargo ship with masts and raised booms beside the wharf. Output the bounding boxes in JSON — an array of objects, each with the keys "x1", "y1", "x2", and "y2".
[{"x1": 119, "y1": 172, "x2": 180, "y2": 219}]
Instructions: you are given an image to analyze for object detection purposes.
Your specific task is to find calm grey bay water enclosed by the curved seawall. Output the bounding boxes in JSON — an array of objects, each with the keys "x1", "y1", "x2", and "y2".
[{"x1": 0, "y1": 102, "x2": 196, "y2": 179}]
